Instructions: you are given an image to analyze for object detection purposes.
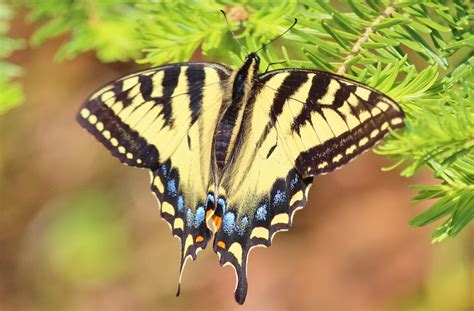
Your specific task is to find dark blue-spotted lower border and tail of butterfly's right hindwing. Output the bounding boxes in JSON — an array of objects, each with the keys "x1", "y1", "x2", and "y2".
[{"x1": 214, "y1": 167, "x2": 312, "y2": 304}]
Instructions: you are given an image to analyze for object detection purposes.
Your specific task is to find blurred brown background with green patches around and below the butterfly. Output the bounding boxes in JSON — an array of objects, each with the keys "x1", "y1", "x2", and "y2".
[{"x1": 0, "y1": 18, "x2": 473, "y2": 311}]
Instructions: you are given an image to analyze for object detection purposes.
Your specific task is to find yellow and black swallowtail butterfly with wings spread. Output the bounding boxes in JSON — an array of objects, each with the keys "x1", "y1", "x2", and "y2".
[{"x1": 77, "y1": 26, "x2": 404, "y2": 304}]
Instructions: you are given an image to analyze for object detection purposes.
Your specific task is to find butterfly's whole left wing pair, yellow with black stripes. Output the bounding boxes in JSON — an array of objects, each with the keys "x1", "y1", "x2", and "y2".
[{"x1": 78, "y1": 63, "x2": 230, "y2": 276}]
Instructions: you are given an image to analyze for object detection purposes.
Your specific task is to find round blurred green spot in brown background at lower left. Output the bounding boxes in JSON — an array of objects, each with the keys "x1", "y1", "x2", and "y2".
[{"x1": 43, "y1": 192, "x2": 130, "y2": 286}]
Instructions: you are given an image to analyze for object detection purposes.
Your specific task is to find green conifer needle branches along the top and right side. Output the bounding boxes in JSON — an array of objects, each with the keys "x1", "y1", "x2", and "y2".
[{"x1": 1, "y1": 0, "x2": 474, "y2": 241}]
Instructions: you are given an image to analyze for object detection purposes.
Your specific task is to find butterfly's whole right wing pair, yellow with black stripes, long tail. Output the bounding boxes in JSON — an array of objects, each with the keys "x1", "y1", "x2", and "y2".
[{"x1": 214, "y1": 70, "x2": 403, "y2": 303}]
